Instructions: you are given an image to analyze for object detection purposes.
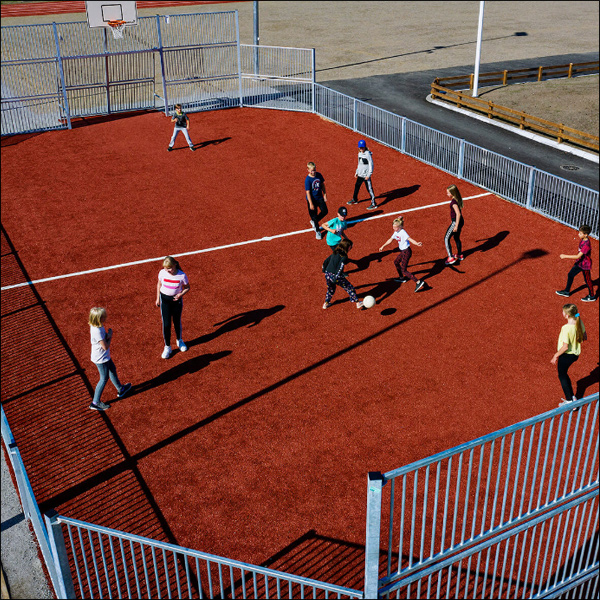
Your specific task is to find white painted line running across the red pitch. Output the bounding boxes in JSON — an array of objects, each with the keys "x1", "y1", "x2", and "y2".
[{"x1": 0, "y1": 192, "x2": 491, "y2": 292}]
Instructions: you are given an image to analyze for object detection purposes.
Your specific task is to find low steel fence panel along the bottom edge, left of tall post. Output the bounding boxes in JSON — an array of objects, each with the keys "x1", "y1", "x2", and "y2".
[{"x1": 50, "y1": 515, "x2": 363, "y2": 598}]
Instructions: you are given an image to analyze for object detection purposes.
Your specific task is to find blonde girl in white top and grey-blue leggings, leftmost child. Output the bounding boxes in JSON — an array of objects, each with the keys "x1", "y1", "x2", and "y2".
[{"x1": 88, "y1": 306, "x2": 131, "y2": 411}]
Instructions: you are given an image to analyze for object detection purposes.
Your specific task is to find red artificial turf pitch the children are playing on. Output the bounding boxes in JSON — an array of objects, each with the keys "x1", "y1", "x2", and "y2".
[{"x1": 2, "y1": 108, "x2": 598, "y2": 587}]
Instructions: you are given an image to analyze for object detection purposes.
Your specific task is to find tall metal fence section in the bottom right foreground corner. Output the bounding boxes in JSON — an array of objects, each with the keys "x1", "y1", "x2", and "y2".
[{"x1": 365, "y1": 393, "x2": 599, "y2": 598}]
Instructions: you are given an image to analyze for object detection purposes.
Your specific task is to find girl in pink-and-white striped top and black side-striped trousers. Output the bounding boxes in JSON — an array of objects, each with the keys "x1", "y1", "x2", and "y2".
[{"x1": 156, "y1": 256, "x2": 190, "y2": 358}]
